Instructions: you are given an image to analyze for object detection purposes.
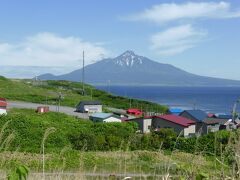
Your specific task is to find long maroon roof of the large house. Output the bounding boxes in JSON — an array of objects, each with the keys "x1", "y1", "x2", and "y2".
[{"x1": 153, "y1": 114, "x2": 195, "y2": 127}]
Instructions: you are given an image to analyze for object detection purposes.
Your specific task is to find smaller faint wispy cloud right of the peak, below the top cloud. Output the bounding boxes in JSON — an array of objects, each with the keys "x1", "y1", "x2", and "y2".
[{"x1": 150, "y1": 24, "x2": 207, "y2": 55}]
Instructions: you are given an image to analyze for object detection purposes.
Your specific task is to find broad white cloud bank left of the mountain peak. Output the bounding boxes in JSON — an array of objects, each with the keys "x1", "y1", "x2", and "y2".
[{"x1": 0, "y1": 33, "x2": 109, "y2": 66}]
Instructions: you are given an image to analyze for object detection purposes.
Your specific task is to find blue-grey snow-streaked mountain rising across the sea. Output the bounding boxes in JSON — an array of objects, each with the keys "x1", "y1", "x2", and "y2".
[{"x1": 38, "y1": 51, "x2": 240, "y2": 86}]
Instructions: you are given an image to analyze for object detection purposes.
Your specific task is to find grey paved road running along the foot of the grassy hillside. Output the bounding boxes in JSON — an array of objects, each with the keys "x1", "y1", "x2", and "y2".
[{"x1": 8, "y1": 101, "x2": 89, "y2": 119}]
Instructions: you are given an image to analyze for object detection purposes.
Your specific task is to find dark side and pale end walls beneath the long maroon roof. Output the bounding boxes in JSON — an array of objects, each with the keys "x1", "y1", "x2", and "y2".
[{"x1": 152, "y1": 118, "x2": 190, "y2": 136}]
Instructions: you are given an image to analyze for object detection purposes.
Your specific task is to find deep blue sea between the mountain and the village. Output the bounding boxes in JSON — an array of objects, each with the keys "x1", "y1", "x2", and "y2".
[{"x1": 97, "y1": 86, "x2": 240, "y2": 114}]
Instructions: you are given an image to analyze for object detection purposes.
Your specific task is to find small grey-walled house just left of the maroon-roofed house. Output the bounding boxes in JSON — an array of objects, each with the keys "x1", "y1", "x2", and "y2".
[{"x1": 127, "y1": 117, "x2": 152, "y2": 134}]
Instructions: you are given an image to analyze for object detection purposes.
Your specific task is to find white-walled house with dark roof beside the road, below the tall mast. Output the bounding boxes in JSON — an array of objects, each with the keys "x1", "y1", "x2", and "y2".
[{"x1": 76, "y1": 101, "x2": 102, "y2": 113}]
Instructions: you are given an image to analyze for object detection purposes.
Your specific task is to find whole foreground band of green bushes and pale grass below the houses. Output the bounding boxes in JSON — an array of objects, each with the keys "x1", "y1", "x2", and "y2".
[{"x1": 0, "y1": 109, "x2": 240, "y2": 179}]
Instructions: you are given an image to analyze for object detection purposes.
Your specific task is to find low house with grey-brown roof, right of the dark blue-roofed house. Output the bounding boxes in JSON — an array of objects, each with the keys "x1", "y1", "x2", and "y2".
[{"x1": 202, "y1": 118, "x2": 232, "y2": 134}]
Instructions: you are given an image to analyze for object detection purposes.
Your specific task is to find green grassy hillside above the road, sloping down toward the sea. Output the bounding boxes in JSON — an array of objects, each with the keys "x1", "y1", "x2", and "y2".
[{"x1": 0, "y1": 77, "x2": 167, "y2": 112}]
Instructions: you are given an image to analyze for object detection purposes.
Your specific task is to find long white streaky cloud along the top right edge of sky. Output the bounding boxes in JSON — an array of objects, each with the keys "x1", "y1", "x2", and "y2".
[{"x1": 124, "y1": 1, "x2": 240, "y2": 24}]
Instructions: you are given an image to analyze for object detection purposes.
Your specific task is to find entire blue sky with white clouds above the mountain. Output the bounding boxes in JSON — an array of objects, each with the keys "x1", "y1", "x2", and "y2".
[{"x1": 0, "y1": 0, "x2": 240, "y2": 80}]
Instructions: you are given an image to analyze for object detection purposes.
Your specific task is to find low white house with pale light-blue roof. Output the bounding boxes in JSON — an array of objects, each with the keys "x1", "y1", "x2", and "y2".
[{"x1": 89, "y1": 113, "x2": 122, "y2": 122}]
